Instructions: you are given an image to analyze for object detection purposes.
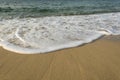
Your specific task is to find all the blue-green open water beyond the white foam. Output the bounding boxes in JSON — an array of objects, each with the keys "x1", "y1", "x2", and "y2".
[{"x1": 0, "y1": 0, "x2": 120, "y2": 18}]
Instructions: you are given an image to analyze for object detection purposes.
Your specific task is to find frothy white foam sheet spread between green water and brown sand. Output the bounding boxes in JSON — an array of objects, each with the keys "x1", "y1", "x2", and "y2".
[{"x1": 0, "y1": 13, "x2": 120, "y2": 54}]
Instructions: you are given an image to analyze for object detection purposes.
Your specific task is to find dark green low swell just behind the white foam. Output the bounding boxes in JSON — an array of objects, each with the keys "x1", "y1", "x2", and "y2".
[{"x1": 0, "y1": 6, "x2": 120, "y2": 18}]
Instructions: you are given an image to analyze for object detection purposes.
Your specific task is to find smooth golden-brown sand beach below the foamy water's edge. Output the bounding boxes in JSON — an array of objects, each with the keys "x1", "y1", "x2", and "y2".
[{"x1": 0, "y1": 36, "x2": 120, "y2": 80}]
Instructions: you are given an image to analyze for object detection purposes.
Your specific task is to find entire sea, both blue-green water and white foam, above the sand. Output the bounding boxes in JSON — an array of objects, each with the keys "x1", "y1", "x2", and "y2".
[{"x1": 0, "y1": 0, "x2": 120, "y2": 54}]
